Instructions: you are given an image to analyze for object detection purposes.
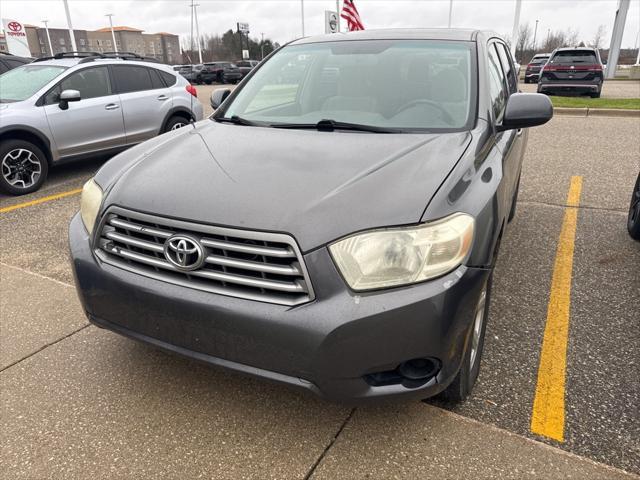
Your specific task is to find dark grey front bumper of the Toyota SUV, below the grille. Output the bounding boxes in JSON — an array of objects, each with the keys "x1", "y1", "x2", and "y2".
[{"x1": 69, "y1": 215, "x2": 490, "y2": 402}]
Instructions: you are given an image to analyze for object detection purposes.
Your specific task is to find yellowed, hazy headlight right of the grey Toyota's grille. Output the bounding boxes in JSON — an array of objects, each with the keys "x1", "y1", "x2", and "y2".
[{"x1": 329, "y1": 213, "x2": 474, "y2": 290}]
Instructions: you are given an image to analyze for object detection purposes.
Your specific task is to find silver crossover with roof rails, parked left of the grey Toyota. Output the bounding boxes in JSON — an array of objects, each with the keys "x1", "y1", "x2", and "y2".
[{"x1": 0, "y1": 52, "x2": 203, "y2": 195}]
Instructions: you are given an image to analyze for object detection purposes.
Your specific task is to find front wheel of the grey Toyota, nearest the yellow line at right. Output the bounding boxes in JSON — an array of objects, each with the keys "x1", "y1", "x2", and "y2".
[{"x1": 442, "y1": 273, "x2": 493, "y2": 403}]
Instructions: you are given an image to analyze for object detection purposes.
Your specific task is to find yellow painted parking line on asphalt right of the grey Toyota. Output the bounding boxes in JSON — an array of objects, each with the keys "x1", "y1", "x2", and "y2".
[{"x1": 531, "y1": 177, "x2": 582, "y2": 442}]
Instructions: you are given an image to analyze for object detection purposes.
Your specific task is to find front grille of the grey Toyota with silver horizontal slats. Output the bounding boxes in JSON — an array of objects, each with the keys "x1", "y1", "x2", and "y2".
[{"x1": 95, "y1": 207, "x2": 314, "y2": 306}]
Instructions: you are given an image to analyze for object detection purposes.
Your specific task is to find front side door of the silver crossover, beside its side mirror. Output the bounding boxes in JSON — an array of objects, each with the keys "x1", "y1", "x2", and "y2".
[{"x1": 42, "y1": 65, "x2": 125, "y2": 157}]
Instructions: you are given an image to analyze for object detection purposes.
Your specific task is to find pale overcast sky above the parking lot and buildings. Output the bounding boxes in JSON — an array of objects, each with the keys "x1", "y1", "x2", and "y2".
[{"x1": 0, "y1": 0, "x2": 640, "y2": 48}]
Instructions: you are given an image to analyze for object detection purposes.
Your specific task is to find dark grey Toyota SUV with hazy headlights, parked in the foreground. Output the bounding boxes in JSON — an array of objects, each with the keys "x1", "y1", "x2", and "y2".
[{"x1": 69, "y1": 29, "x2": 553, "y2": 401}]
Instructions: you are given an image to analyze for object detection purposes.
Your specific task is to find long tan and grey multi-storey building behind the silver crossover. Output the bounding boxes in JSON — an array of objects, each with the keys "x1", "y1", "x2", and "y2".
[{"x1": 0, "y1": 24, "x2": 182, "y2": 65}]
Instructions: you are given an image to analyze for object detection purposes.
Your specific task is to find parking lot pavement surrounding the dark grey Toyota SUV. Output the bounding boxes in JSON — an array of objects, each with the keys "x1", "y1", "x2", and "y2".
[{"x1": 0, "y1": 82, "x2": 640, "y2": 479}]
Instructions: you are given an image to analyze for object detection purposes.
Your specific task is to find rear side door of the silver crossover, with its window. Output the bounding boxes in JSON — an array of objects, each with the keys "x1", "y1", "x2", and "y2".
[{"x1": 112, "y1": 65, "x2": 173, "y2": 145}]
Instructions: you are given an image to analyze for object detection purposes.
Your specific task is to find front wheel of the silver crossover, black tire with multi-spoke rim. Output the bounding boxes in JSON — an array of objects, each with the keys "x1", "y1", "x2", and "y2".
[{"x1": 0, "y1": 140, "x2": 49, "y2": 195}]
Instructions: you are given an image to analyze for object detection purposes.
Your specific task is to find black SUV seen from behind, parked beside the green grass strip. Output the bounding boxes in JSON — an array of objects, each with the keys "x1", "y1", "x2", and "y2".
[{"x1": 538, "y1": 47, "x2": 604, "y2": 98}]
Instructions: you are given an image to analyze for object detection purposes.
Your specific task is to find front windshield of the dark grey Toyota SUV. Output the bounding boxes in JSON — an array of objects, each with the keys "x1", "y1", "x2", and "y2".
[{"x1": 216, "y1": 40, "x2": 476, "y2": 131}]
